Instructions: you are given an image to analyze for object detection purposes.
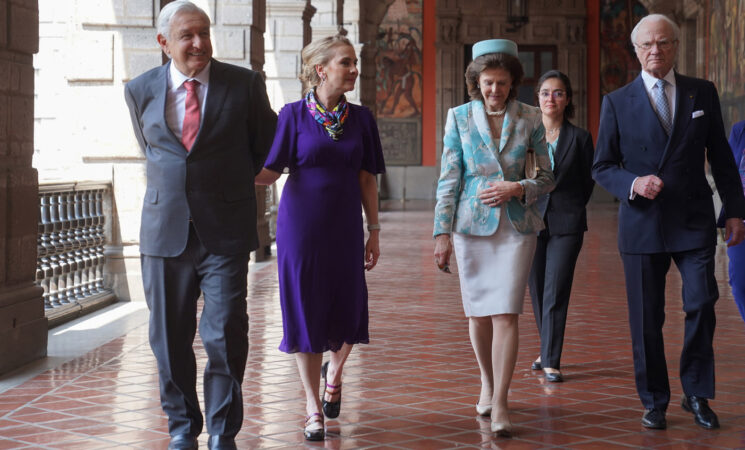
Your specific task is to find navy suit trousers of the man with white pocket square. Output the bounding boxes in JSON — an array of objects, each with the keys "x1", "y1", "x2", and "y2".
[{"x1": 621, "y1": 246, "x2": 719, "y2": 410}]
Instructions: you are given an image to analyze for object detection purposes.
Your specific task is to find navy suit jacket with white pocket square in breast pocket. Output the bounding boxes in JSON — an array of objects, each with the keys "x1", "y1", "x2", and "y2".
[{"x1": 593, "y1": 73, "x2": 745, "y2": 254}]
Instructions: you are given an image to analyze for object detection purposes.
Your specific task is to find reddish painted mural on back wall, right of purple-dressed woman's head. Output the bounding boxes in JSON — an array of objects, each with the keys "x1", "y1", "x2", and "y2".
[{"x1": 375, "y1": 0, "x2": 422, "y2": 118}]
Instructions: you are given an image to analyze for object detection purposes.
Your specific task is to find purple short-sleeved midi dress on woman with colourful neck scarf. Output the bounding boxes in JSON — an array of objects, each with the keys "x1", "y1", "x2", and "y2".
[{"x1": 264, "y1": 100, "x2": 385, "y2": 353}]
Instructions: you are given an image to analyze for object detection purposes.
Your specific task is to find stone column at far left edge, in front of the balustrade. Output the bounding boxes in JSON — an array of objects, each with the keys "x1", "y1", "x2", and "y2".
[{"x1": 0, "y1": 0, "x2": 47, "y2": 374}]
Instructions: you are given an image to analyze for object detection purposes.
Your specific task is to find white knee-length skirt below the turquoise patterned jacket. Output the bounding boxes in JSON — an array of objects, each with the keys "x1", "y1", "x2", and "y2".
[{"x1": 453, "y1": 207, "x2": 536, "y2": 317}]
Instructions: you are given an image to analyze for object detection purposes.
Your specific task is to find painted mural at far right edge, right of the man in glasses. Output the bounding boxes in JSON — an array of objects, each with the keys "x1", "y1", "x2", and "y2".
[{"x1": 707, "y1": 0, "x2": 745, "y2": 133}]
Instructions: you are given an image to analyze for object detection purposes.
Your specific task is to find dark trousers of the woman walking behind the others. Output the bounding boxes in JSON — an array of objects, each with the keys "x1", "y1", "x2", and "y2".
[{"x1": 528, "y1": 232, "x2": 584, "y2": 369}]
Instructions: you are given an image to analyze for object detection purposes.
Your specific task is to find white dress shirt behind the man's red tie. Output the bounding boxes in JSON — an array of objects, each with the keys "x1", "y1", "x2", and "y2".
[{"x1": 166, "y1": 61, "x2": 212, "y2": 141}]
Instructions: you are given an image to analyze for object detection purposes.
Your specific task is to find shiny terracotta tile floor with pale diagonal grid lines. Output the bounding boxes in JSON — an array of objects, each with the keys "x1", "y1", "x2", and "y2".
[{"x1": 0, "y1": 205, "x2": 745, "y2": 450}]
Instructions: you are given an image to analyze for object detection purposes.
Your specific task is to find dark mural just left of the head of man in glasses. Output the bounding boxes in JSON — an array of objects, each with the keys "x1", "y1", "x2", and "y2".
[{"x1": 600, "y1": 0, "x2": 647, "y2": 95}]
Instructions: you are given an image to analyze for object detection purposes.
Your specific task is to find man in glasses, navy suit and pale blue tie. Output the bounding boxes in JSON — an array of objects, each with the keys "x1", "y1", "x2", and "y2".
[{"x1": 593, "y1": 14, "x2": 745, "y2": 429}]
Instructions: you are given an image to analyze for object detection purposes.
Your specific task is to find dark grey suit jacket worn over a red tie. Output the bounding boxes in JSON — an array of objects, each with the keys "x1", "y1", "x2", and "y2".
[{"x1": 125, "y1": 59, "x2": 277, "y2": 257}]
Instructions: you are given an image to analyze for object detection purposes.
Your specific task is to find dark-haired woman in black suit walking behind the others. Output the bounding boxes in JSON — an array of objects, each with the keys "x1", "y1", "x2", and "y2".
[{"x1": 528, "y1": 70, "x2": 595, "y2": 382}]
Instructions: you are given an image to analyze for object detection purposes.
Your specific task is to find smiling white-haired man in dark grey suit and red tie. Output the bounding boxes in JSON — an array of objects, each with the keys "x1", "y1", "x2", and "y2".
[{"x1": 125, "y1": 0, "x2": 276, "y2": 449}]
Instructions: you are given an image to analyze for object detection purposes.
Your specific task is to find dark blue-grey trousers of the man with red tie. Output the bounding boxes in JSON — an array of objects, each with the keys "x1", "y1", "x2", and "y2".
[{"x1": 141, "y1": 227, "x2": 250, "y2": 437}]
